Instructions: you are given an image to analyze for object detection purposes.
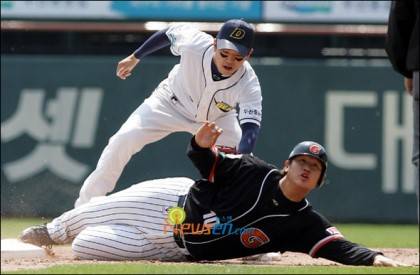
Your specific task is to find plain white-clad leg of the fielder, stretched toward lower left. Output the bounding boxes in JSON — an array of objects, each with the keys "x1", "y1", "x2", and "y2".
[{"x1": 75, "y1": 91, "x2": 187, "y2": 207}]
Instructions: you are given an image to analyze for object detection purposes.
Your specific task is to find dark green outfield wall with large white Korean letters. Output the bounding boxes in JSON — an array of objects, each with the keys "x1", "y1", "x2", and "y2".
[{"x1": 1, "y1": 56, "x2": 417, "y2": 223}]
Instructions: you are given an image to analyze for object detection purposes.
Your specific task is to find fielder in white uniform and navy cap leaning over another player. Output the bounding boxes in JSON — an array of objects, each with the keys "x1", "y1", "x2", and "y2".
[{"x1": 75, "y1": 20, "x2": 262, "y2": 207}]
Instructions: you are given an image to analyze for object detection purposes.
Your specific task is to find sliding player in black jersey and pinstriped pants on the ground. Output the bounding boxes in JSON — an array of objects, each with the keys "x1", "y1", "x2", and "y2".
[{"x1": 20, "y1": 122, "x2": 401, "y2": 266}]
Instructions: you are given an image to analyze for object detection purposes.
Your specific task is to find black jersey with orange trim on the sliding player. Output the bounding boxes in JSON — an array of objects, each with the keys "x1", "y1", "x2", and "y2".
[{"x1": 181, "y1": 138, "x2": 379, "y2": 265}]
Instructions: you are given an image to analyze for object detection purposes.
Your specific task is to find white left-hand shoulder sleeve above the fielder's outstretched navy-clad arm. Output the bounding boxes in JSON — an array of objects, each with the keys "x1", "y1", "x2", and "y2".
[{"x1": 166, "y1": 23, "x2": 213, "y2": 56}]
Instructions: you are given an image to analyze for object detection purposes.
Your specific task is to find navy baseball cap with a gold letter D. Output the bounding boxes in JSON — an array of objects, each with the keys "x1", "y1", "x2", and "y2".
[{"x1": 216, "y1": 19, "x2": 254, "y2": 56}]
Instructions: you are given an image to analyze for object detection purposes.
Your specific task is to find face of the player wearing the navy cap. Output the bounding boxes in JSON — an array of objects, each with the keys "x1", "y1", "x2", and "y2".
[{"x1": 213, "y1": 49, "x2": 249, "y2": 76}]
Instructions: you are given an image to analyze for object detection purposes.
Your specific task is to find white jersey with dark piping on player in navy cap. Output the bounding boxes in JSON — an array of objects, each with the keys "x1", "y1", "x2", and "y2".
[{"x1": 163, "y1": 24, "x2": 262, "y2": 125}]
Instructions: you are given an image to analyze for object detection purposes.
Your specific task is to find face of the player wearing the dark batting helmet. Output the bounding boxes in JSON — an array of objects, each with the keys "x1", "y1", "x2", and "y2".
[{"x1": 287, "y1": 156, "x2": 322, "y2": 191}]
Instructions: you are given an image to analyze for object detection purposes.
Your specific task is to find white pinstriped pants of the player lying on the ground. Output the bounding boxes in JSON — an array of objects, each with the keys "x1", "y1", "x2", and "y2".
[{"x1": 47, "y1": 178, "x2": 194, "y2": 261}]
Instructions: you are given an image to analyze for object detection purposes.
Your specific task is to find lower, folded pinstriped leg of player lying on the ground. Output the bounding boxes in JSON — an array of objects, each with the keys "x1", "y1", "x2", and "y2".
[{"x1": 72, "y1": 224, "x2": 185, "y2": 261}]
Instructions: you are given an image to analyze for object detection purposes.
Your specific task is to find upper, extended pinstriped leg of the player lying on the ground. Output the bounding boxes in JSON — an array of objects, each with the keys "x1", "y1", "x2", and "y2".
[{"x1": 47, "y1": 178, "x2": 194, "y2": 244}]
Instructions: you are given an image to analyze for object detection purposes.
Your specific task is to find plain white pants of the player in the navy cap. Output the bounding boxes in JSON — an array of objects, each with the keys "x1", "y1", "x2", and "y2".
[{"x1": 75, "y1": 86, "x2": 242, "y2": 207}]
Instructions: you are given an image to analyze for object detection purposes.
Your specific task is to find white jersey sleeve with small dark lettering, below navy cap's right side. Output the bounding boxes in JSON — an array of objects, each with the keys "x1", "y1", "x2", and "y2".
[{"x1": 238, "y1": 70, "x2": 262, "y2": 126}]
